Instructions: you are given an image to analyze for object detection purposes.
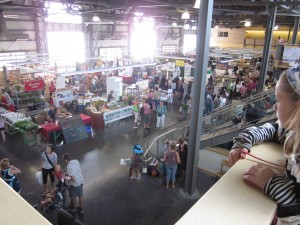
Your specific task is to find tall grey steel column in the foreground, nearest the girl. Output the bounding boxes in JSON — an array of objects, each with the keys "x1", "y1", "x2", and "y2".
[{"x1": 185, "y1": 0, "x2": 214, "y2": 195}]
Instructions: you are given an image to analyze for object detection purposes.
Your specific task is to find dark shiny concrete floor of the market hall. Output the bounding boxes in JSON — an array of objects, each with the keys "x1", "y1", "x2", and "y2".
[{"x1": 0, "y1": 104, "x2": 217, "y2": 225}]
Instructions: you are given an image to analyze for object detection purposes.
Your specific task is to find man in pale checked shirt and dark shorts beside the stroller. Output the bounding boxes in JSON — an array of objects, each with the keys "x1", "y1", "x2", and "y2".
[{"x1": 63, "y1": 153, "x2": 83, "y2": 213}]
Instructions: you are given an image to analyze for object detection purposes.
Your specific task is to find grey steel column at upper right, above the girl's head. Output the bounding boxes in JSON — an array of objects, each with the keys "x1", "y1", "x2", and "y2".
[{"x1": 258, "y1": 4, "x2": 277, "y2": 92}]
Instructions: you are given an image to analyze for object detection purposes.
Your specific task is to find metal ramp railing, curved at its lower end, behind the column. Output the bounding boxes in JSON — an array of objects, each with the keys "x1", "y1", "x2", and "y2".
[{"x1": 141, "y1": 89, "x2": 276, "y2": 159}]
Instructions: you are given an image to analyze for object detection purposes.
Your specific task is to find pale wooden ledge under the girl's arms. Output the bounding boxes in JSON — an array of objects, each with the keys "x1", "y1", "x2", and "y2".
[{"x1": 176, "y1": 143, "x2": 284, "y2": 225}]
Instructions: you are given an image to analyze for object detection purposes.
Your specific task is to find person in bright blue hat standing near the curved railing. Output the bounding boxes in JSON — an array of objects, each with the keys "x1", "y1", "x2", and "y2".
[{"x1": 130, "y1": 145, "x2": 143, "y2": 183}]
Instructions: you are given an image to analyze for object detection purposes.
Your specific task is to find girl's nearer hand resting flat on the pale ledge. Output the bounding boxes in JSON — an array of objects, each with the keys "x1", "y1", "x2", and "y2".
[{"x1": 243, "y1": 164, "x2": 276, "y2": 190}]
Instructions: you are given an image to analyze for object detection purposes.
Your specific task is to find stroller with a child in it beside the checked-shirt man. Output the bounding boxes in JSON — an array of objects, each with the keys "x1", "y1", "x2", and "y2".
[{"x1": 41, "y1": 182, "x2": 68, "y2": 214}]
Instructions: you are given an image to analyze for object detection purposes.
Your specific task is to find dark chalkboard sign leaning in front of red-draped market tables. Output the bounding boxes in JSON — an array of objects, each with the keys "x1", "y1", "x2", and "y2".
[{"x1": 59, "y1": 115, "x2": 88, "y2": 144}]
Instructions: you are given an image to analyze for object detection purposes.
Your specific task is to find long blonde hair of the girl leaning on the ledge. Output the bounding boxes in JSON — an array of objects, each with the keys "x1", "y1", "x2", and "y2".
[{"x1": 279, "y1": 71, "x2": 300, "y2": 155}]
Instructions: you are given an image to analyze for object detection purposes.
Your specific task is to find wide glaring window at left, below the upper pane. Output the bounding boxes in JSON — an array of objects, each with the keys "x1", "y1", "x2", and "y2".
[{"x1": 47, "y1": 31, "x2": 85, "y2": 65}]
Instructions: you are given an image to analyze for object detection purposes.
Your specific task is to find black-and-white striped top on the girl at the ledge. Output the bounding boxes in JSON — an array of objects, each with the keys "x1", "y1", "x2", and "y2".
[{"x1": 232, "y1": 122, "x2": 300, "y2": 217}]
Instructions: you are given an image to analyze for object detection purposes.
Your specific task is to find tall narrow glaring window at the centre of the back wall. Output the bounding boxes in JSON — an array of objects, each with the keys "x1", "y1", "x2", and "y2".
[{"x1": 131, "y1": 17, "x2": 156, "y2": 59}]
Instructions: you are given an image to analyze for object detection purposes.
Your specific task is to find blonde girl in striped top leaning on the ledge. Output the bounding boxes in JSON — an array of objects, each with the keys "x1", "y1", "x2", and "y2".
[{"x1": 229, "y1": 66, "x2": 300, "y2": 225}]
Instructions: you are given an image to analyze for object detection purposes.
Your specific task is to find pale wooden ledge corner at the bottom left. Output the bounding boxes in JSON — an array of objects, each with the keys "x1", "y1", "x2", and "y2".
[{"x1": 0, "y1": 179, "x2": 51, "y2": 225}]
